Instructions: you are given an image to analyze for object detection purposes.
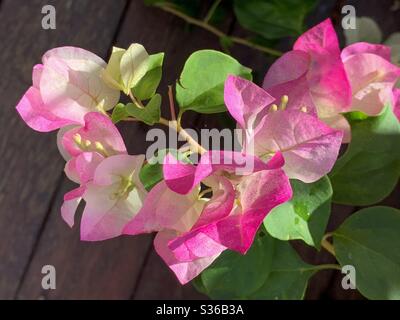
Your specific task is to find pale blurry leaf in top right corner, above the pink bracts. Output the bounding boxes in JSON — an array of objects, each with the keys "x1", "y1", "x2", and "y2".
[{"x1": 343, "y1": 17, "x2": 382, "y2": 45}]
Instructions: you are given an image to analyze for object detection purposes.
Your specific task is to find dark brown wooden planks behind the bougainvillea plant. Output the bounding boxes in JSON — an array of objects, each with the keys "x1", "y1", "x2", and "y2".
[{"x1": 0, "y1": 0, "x2": 400, "y2": 299}]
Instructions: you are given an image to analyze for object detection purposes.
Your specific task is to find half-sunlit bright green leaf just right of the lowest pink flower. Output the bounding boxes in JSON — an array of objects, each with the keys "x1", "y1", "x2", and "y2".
[{"x1": 264, "y1": 177, "x2": 332, "y2": 249}]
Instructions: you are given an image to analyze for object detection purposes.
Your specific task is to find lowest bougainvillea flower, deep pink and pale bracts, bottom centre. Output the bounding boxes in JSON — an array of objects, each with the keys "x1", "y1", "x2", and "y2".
[{"x1": 123, "y1": 151, "x2": 292, "y2": 283}]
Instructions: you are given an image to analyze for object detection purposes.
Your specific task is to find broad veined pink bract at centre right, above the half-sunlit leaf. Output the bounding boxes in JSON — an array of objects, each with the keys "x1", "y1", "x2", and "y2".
[{"x1": 251, "y1": 110, "x2": 343, "y2": 183}]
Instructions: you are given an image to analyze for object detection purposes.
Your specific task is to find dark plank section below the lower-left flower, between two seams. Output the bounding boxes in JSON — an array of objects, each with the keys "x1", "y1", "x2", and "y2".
[{"x1": 18, "y1": 180, "x2": 151, "y2": 299}]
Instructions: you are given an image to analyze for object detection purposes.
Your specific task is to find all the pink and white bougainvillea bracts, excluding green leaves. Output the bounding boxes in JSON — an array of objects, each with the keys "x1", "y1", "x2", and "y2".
[{"x1": 17, "y1": 20, "x2": 400, "y2": 283}]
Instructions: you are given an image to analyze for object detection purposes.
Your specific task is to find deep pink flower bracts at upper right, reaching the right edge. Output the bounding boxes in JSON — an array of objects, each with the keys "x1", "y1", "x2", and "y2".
[{"x1": 263, "y1": 19, "x2": 400, "y2": 142}]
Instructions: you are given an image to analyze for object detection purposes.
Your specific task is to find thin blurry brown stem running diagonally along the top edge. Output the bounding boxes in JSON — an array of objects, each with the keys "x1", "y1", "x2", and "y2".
[{"x1": 155, "y1": 4, "x2": 282, "y2": 57}]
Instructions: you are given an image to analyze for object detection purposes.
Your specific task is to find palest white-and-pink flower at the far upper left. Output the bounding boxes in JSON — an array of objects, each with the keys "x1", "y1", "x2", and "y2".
[{"x1": 17, "y1": 47, "x2": 120, "y2": 132}]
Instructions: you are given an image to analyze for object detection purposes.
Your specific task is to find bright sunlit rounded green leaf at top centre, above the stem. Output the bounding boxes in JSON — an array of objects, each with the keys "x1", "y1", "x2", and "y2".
[{"x1": 176, "y1": 50, "x2": 251, "y2": 113}]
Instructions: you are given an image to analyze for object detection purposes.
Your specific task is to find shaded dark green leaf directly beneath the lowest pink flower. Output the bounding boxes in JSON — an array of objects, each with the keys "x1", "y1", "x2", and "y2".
[{"x1": 197, "y1": 233, "x2": 321, "y2": 299}]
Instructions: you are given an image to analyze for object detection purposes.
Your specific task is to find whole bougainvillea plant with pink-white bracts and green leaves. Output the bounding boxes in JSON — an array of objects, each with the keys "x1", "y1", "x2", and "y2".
[{"x1": 17, "y1": 20, "x2": 400, "y2": 299}]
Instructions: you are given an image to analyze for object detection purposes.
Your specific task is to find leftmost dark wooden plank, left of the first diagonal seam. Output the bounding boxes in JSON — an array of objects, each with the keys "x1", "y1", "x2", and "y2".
[{"x1": 0, "y1": 0, "x2": 125, "y2": 299}]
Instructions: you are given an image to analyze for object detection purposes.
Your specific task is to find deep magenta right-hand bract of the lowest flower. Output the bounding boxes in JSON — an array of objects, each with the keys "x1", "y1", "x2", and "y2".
[{"x1": 170, "y1": 169, "x2": 292, "y2": 254}]
